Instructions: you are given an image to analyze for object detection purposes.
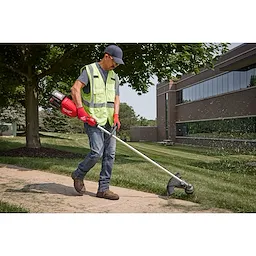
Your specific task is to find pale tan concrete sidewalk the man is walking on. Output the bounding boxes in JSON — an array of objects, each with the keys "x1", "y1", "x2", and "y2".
[{"x1": 0, "y1": 164, "x2": 226, "y2": 213}]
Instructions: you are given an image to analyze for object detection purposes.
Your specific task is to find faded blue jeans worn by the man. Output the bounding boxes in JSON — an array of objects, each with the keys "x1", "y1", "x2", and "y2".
[{"x1": 74, "y1": 123, "x2": 116, "y2": 192}]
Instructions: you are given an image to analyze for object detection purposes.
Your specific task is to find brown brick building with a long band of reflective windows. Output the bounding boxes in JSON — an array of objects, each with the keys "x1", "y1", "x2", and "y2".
[{"x1": 156, "y1": 43, "x2": 256, "y2": 148}]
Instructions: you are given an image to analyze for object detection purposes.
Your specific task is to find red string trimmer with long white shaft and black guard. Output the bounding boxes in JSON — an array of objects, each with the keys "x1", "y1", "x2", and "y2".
[{"x1": 50, "y1": 90, "x2": 194, "y2": 196}]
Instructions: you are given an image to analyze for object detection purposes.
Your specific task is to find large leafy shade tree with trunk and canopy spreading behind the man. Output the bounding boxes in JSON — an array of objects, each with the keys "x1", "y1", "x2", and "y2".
[{"x1": 0, "y1": 43, "x2": 228, "y2": 148}]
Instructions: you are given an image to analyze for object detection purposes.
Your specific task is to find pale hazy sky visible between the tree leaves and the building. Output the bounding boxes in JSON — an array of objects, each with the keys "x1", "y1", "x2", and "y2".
[{"x1": 120, "y1": 43, "x2": 241, "y2": 120}]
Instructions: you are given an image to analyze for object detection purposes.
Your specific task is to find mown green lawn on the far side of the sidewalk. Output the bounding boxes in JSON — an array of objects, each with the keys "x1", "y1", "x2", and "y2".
[{"x1": 0, "y1": 133, "x2": 256, "y2": 212}]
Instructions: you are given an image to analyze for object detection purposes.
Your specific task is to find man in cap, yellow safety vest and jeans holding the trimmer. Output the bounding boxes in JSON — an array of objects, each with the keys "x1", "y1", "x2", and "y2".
[{"x1": 71, "y1": 45, "x2": 124, "y2": 200}]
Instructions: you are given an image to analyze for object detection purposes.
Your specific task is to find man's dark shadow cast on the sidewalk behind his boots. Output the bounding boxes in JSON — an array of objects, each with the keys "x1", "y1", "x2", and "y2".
[{"x1": 6, "y1": 183, "x2": 96, "y2": 197}]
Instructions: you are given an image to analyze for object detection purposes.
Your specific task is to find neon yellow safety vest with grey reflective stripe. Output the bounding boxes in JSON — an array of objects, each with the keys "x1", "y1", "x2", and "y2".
[{"x1": 81, "y1": 63, "x2": 116, "y2": 126}]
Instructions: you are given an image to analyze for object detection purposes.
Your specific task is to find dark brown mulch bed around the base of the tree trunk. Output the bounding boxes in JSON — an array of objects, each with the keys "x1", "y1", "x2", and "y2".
[{"x1": 0, "y1": 147, "x2": 84, "y2": 159}]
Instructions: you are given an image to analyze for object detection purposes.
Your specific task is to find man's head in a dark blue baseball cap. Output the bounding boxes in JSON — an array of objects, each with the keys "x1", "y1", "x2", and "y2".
[{"x1": 100, "y1": 45, "x2": 124, "y2": 70}]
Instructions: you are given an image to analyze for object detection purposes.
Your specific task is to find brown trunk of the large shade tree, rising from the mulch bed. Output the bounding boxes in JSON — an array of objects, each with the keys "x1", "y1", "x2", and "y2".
[{"x1": 25, "y1": 75, "x2": 41, "y2": 148}]
